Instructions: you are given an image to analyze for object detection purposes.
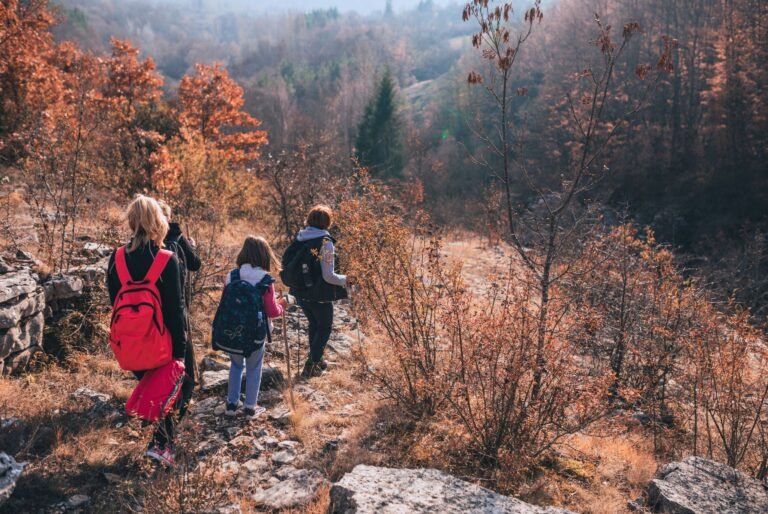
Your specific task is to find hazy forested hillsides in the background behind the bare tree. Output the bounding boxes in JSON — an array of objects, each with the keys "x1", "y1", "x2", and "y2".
[{"x1": 56, "y1": 0, "x2": 768, "y2": 312}]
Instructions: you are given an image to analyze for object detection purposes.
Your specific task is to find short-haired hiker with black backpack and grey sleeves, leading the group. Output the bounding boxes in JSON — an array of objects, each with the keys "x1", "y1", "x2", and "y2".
[{"x1": 281, "y1": 206, "x2": 348, "y2": 378}]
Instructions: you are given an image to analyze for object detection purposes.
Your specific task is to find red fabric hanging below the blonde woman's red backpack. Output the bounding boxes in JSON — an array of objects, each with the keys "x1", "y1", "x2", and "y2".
[{"x1": 125, "y1": 360, "x2": 184, "y2": 423}]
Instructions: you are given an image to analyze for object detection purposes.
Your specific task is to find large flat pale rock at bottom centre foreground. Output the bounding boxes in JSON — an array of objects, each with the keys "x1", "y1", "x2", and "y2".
[{"x1": 331, "y1": 465, "x2": 567, "y2": 514}]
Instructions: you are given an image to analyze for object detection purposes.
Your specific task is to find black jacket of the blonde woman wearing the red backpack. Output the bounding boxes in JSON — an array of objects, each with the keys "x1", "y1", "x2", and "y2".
[{"x1": 107, "y1": 243, "x2": 187, "y2": 359}]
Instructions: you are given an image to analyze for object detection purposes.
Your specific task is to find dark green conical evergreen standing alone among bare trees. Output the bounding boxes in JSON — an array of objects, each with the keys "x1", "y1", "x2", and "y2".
[{"x1": 355, "y1": 69, "x2": 403, "y2": 177}]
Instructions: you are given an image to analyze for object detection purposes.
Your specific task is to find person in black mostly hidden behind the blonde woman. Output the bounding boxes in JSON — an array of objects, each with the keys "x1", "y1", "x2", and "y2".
[{"x1": 159, "y1": 201, "x2": 202, "y2": 419}]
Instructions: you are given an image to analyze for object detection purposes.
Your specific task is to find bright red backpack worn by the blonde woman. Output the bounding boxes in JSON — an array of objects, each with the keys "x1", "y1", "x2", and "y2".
[{"x1": 109, "y1": 246, "x2": 173, "y2": 371}]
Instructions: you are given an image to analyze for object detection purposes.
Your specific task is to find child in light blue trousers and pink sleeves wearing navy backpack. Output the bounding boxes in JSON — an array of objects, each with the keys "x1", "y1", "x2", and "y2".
[{"x1": 213, "y1": 236, "x2": 288, "y2": 420}]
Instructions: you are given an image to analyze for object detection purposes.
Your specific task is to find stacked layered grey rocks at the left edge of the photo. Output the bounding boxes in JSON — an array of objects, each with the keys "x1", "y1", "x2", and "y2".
[{"x1": 0, "y1": 269, "x2": 45, "y2": 374}]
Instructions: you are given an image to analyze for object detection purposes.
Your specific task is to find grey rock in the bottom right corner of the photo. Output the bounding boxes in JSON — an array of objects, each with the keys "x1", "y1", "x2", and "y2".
[{"x1": 648, "y1": 457, "x2": 768, "y2": 514}]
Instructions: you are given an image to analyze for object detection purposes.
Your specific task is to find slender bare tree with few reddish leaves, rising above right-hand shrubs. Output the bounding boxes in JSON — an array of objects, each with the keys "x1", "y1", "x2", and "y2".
[{"x1": 463, "y1": 0, "x2": 673, "y2": 400}]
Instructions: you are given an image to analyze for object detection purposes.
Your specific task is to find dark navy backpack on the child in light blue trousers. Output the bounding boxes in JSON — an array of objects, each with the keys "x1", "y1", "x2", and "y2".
[{"x1": 212, "y1": 269, "x2": 275, "y2": 358}]
